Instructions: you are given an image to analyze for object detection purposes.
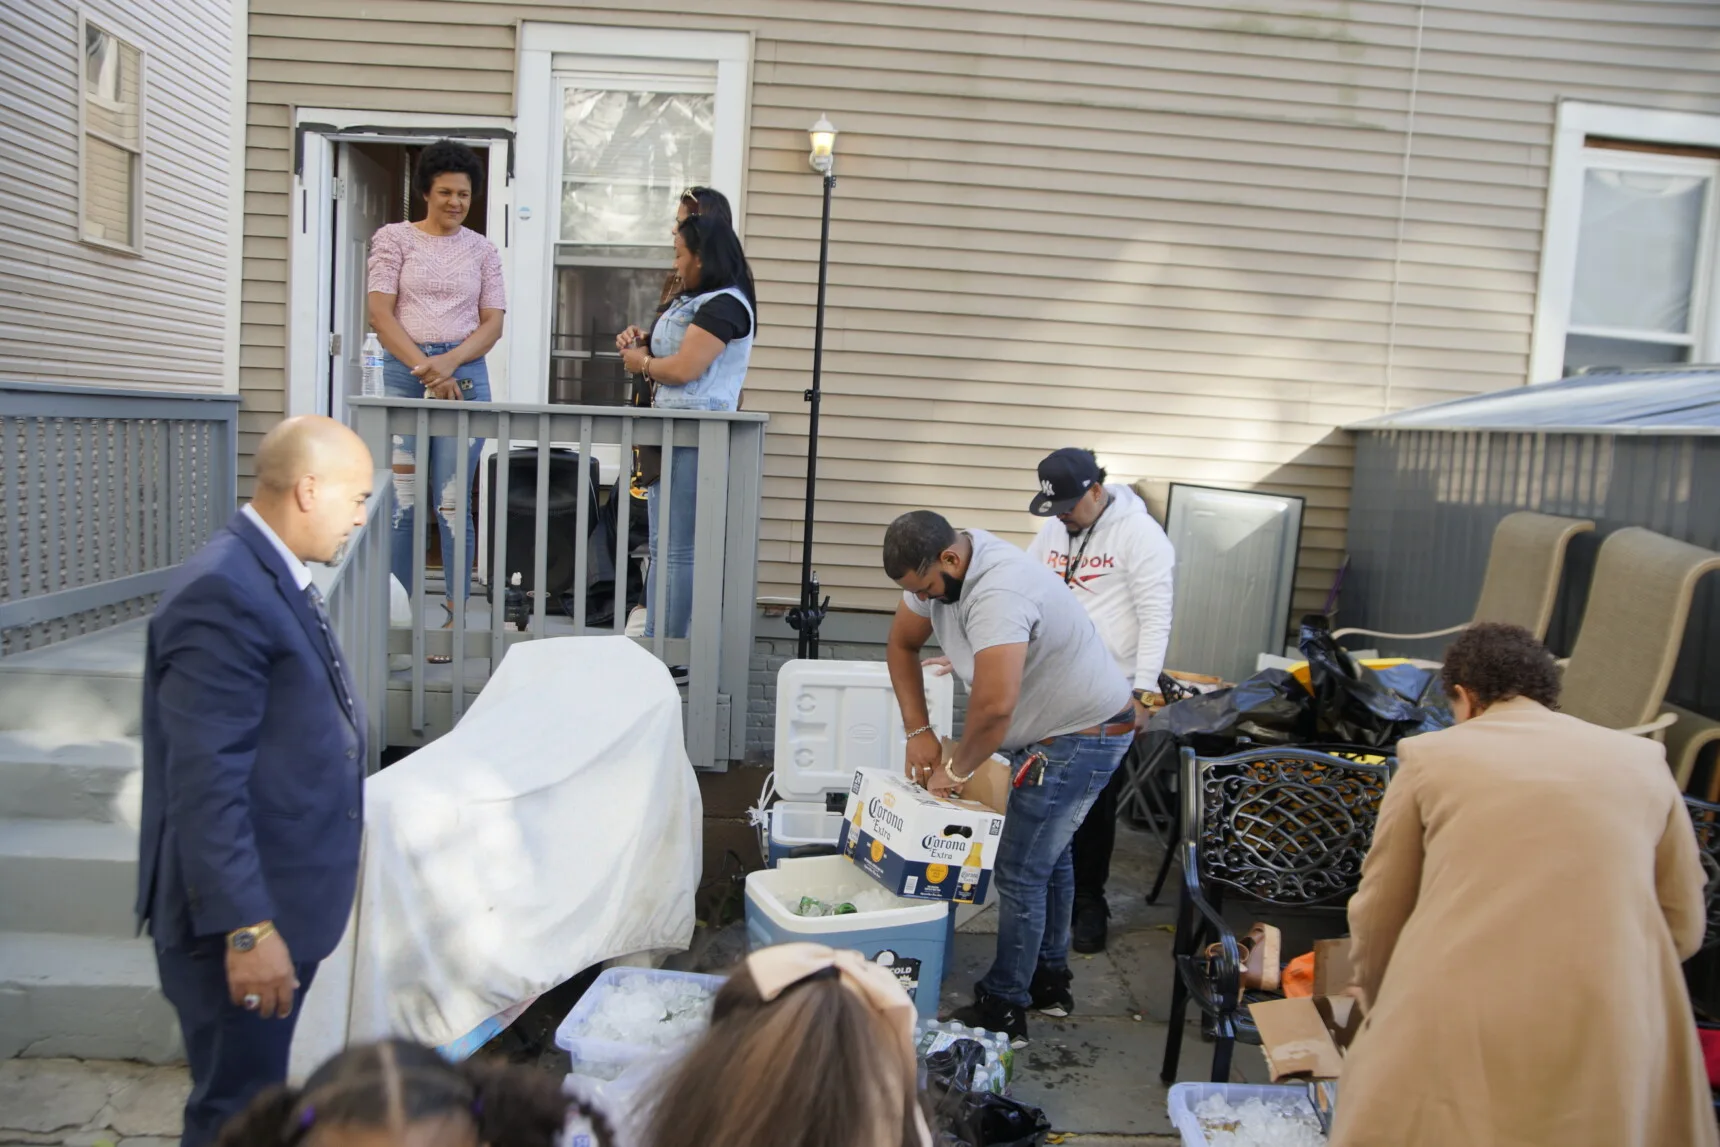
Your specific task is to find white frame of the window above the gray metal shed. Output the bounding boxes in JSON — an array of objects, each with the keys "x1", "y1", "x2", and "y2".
[{"x1": 1529, "y1": 100, "x2": 1720, "y2": 383}]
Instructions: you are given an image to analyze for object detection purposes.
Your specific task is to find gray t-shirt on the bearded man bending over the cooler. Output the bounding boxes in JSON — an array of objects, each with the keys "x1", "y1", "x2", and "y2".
[{"x1": 901, "y1": 530, "x2": 1128, "y2": 748}]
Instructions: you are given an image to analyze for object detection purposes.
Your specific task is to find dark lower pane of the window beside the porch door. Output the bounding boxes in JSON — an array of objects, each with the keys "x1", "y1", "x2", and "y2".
[{"x1": 549, "y1": 267, "x2": 667, "y2": 406}]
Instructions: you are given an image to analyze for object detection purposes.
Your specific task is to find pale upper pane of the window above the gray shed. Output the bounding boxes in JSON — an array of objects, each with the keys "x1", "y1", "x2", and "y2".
[{"x1": 1570, "y1": 170, "x2": 1708, "y2": 334}]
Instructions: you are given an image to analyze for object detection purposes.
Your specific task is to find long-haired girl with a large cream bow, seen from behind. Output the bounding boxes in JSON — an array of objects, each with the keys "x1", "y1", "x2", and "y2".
[{"x1": 642, "y1": 944, "x2": 932, "y2": 1147}]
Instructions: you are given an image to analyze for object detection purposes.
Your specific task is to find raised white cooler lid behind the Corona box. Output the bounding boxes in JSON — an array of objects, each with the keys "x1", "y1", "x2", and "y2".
[{"x1": 776, "y1": 660, "x2": 955, "y2": 801}]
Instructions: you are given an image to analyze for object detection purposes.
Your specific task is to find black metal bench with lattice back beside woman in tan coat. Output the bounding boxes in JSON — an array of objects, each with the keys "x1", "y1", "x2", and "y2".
[{"x1": 1159, "y1": 746, "x2": 1397, "y2": 1083}]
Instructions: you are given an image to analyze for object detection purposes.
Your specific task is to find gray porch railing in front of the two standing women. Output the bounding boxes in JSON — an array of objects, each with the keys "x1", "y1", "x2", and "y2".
[{"x1": 351, "y1": 397, "x2": 769, "y2": 769}]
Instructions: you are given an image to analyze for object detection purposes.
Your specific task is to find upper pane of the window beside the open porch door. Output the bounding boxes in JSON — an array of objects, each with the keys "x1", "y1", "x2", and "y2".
[{"x1": 561, "y1": 88, "x2": 716, "y2": 246}]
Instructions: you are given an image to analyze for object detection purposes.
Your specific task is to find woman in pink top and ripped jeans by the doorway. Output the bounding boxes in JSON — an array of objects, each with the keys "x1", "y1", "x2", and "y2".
[{"x1": 370, "y1": 139, "x2": 507, "y2": 636}]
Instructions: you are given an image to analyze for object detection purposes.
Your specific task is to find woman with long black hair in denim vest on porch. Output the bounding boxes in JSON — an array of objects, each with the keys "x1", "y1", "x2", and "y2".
[{"x1": 621, "y1": 215, "x2": 757, "y2": 653}]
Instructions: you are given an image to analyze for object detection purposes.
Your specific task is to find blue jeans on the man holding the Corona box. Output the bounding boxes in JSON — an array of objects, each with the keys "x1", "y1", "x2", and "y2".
[{"x1": 979, "y1": 733, "x2": 1133, "y2": 1008}]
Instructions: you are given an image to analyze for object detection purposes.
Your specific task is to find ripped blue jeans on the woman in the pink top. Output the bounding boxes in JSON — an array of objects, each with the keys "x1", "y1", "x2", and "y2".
[{"x1": 382, "y1": 342, "x2": 490, "y2": 602}]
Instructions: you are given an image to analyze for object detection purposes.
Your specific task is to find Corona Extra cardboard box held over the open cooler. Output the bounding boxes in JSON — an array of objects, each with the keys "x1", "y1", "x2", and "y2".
[{"x1": 838, "y1": 762, "x2": 1010, "y2": 905}]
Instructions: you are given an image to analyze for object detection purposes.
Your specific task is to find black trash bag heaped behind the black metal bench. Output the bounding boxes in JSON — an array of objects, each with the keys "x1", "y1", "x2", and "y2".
[{"x1": 1299, "y1": 626, "x2": 1452, "y2": 748}]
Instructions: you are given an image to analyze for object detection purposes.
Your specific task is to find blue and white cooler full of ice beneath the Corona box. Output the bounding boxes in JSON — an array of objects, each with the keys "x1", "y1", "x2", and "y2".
[{"x1": 746, "y1": 856, "x2": 955, "y2": 1020}]
